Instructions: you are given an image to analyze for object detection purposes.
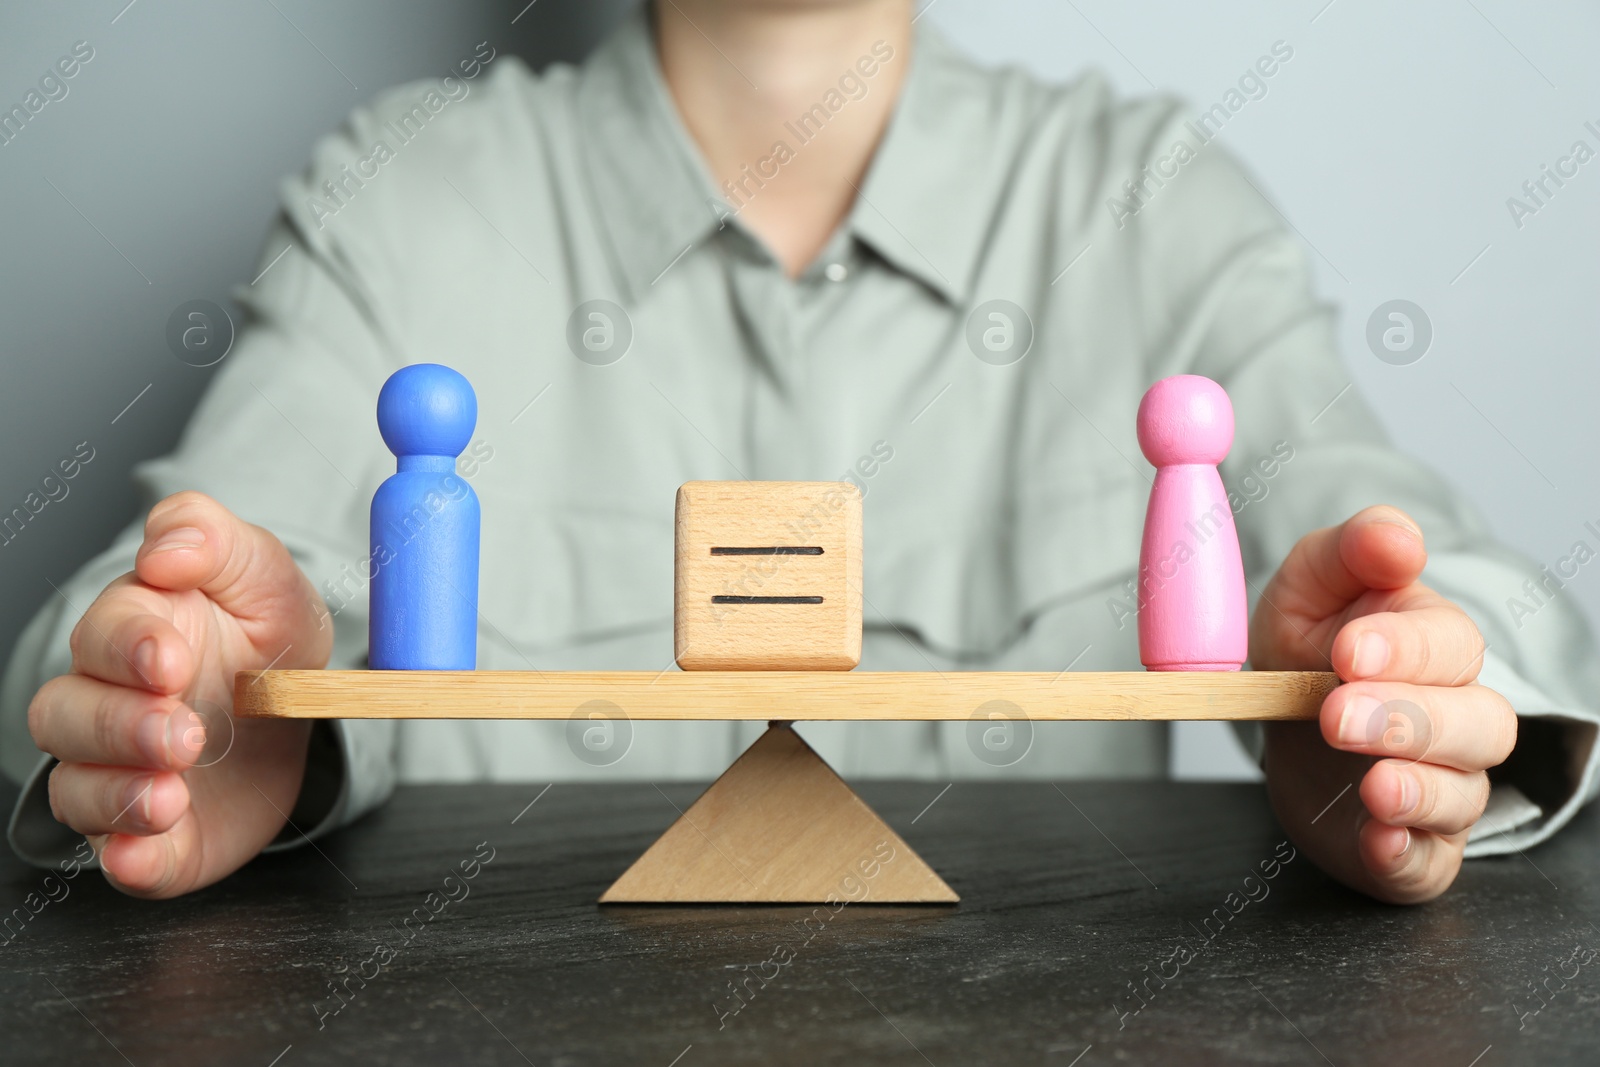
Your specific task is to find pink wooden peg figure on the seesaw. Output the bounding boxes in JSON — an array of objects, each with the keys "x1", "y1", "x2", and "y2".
[{"x1": 1139, "y1": 374, "x2": 1250, "y2": 670}]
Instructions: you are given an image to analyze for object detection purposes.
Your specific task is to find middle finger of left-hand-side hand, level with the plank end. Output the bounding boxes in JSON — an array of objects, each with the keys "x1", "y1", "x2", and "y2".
[{"x1": 27, "y1": 675, "x2": 200, "y2": 771}]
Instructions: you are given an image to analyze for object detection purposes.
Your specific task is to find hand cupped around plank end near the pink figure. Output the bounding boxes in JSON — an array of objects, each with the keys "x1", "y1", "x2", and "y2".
[{"x1": 1250, "y1": 507, "x2": 1517, "y2": 904}]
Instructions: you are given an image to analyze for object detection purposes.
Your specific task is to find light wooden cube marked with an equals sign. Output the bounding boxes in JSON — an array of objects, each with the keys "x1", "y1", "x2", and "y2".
[{"x1": 674, "y1": 482, "x2": 861, "y2": 670}]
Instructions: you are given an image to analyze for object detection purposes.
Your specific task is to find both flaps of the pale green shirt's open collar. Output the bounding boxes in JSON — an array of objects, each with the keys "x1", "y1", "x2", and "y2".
[{"x1": 576, "y1": 5, "x2": 998, "y2": 304}]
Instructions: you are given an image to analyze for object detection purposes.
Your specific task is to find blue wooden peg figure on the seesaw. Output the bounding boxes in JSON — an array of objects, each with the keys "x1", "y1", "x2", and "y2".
[{"x1": 368, "y1": 363, "x2": 482, "y2": 670}]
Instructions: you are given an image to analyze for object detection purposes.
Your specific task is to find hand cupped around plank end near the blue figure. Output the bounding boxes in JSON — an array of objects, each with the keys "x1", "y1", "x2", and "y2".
[{"x1": 27, "y1": 493, "x2": 333, "y2": 897}]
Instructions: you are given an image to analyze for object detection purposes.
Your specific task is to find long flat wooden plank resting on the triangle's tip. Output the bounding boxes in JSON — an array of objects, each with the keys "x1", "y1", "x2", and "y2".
[{"x1": 234, "y1": 670, "x2": 1339, "y2": 720}]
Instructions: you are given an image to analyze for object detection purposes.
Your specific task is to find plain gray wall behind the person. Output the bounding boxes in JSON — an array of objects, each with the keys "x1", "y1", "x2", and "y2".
[{"x1": 0, "y1": 0, "x2": 1600, "y2": 777}]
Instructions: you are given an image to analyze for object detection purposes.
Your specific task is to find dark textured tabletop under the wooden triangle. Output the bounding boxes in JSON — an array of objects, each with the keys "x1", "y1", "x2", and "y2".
[{"x1": 0, "y1": 782, "x2": 1600, "y2": 1067}]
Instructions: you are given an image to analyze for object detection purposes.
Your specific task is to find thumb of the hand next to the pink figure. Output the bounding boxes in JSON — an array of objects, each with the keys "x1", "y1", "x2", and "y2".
[{"x1": 1267, "y1": 506, "x2": 1427, "y2": 619}]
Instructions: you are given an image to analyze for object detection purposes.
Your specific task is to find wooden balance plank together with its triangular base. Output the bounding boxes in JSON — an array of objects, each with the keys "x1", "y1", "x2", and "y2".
[{"x1": 234, "y1": 670, "x2": 1339, "y2": 907}]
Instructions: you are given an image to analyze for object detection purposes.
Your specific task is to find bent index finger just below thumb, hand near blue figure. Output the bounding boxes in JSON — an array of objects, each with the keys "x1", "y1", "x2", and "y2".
[{"x1": 69, "y1": 577, "x2": 194, "y2": 693}]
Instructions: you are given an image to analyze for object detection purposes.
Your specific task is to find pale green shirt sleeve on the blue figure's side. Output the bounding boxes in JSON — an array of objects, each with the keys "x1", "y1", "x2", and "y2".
[{"x1": 0, "y1": 87, "x2": 416, "y2": 864}]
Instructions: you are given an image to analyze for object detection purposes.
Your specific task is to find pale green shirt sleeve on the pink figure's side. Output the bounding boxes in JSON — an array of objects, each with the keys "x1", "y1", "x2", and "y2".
[{"x1": 1126, "y1": 97, "x2": 1600, "y2": 856}]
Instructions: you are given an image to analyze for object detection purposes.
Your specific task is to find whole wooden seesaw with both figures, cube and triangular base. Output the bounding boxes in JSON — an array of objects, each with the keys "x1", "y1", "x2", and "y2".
[{"x1": 234, "y1": 365, "x2": 1339, "y2": 904}]
